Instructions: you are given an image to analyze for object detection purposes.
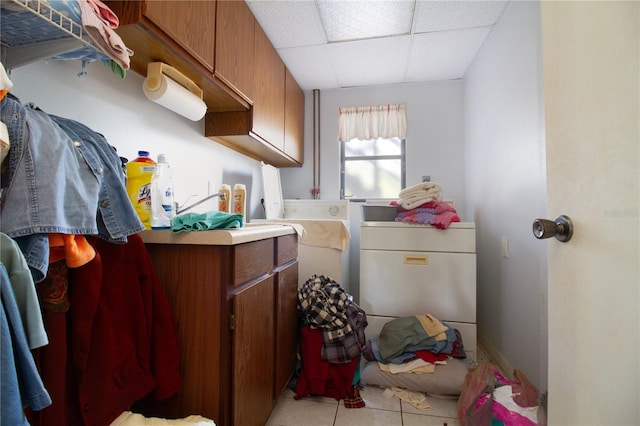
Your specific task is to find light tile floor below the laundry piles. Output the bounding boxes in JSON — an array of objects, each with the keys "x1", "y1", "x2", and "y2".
[{"x1": 266, "y1": 347, "x2": 496, "y2": 426}]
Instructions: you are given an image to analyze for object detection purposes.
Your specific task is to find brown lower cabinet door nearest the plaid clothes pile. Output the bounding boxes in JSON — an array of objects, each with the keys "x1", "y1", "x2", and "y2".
[{"x1": 274, "y1": 262, "x2": 298, "y2": 398}]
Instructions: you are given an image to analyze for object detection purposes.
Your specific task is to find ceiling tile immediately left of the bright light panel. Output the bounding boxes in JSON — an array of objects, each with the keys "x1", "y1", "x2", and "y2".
[{"x1": 247, "y1": 0, "x2": 327, "y2": 49}]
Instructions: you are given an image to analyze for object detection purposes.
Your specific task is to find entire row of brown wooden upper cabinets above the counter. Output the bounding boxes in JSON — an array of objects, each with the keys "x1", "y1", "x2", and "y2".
[{"x1": 105, "y1": 0, "x2": 305, "y2": 167}]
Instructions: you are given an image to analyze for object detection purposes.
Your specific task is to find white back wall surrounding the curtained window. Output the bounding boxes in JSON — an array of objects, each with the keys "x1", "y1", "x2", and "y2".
[{"x1": 280, "y1": 80, "x2": 468, "y2": 301}]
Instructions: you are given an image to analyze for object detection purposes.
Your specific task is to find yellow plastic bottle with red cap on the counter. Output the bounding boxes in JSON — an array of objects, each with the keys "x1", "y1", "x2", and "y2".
[{"x1": 125, "y1": 151, "x2": 156, "y2": 229}]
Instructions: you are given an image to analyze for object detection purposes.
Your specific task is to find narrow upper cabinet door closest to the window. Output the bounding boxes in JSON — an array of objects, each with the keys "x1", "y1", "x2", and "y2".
[{"x1": 284, "y1": 70, "x2": 304, "y2": 164}]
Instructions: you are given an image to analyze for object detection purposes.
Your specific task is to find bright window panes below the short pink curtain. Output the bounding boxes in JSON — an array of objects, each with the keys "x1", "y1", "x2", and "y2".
[{"x1": 340, "y1": 137, "x2": 406, "y2": 201}]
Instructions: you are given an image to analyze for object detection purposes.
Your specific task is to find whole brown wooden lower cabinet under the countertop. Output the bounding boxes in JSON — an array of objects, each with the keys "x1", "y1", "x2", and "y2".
[{"x1": 146, "y1": 234, "x2": 298, "y2": 426}]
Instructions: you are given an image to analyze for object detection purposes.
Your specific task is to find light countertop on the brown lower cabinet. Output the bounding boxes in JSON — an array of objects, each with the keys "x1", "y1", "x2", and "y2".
[{"x1": 140, "y1": 224, "x2": 296, "y2": 246}]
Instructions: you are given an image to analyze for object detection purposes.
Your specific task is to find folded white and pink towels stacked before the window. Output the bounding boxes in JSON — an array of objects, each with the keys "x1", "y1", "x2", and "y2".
[{"x1": 390, "y1": 182, "x2": 460, "y2": 229}]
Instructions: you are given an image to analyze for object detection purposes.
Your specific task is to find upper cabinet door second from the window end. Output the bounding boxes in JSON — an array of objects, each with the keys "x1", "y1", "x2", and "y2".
[{"x1": 253, "y1": 25, "x2": 285, "y2": 152}]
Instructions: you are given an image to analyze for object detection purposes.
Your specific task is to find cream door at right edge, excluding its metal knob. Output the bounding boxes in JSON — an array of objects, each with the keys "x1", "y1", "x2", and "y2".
[{"x1": 541, "y1": 1, "x2": 640, "y2": 425}]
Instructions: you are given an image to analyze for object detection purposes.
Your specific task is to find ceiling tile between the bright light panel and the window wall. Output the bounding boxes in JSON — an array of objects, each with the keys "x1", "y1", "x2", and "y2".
[{"x1": 327, "y1": 36, "x2": 411, "y2": 87}]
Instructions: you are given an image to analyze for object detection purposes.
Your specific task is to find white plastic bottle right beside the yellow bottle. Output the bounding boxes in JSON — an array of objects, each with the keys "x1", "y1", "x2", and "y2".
[{"x1": 151, "y1": 154, "x2": 176, "y2": 229}]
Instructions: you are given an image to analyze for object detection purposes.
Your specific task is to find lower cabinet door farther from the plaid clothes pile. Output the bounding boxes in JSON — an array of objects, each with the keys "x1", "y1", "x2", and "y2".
[{"x1": 231, "y1": 275, "x2": 275, "y2": 425}]
